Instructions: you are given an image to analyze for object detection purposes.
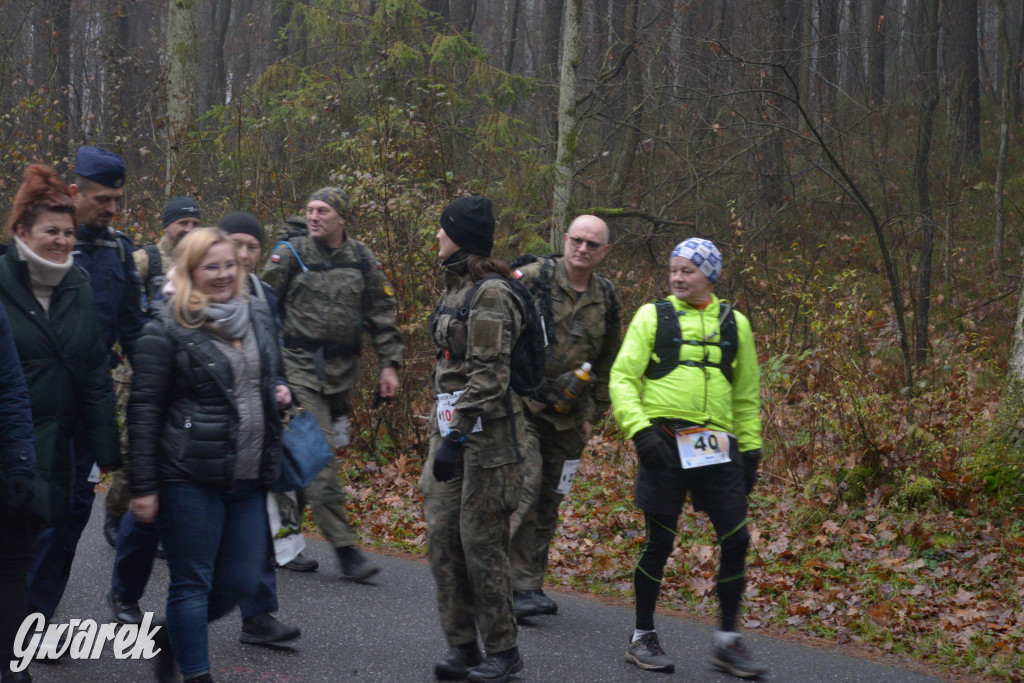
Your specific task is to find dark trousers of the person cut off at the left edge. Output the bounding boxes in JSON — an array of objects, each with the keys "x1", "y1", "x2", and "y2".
[{"x1": 0, "y1": 507, "x2": 32, "y2": 674}]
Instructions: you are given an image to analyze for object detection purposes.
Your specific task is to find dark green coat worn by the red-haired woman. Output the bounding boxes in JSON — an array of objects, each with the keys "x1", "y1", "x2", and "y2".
[{"x1": 0, "y1": 247, "x2": 121, "y2": 525}]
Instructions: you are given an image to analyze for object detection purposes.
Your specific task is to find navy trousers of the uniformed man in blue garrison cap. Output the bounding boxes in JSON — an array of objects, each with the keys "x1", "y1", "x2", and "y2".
[{"x1": 29, "y1": 433, "x2": 96, "y2": 621}]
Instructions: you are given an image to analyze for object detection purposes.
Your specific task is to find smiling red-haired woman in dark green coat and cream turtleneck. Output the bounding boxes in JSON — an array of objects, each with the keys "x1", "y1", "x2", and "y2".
[{"x1": 0, "y1": 164, "x2": 120, "y2": 667}]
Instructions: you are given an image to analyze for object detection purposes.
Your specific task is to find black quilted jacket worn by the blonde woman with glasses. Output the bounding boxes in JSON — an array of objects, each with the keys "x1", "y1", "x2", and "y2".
[{"x1": 128, "y1": 299, "x2": 286, "y2": 497}]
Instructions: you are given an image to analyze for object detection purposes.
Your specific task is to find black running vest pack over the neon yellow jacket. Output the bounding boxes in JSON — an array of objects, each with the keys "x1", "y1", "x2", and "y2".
[{"x1": 644, "y1": 299, "x2": 739, "y2": 384}]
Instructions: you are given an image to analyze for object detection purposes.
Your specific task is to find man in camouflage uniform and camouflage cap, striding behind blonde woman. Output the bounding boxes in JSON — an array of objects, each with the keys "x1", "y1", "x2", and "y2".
[{"x1": 260, "y1": 187, "x2": 402, "y2": 581}]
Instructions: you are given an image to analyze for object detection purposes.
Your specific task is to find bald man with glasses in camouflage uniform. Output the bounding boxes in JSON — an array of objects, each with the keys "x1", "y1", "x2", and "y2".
[{"x1": 510, "y1": 215, "x2": 621, "y2": 618}]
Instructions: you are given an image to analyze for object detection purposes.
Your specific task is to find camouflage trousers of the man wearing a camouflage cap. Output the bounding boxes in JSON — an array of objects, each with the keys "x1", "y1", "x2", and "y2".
[{"x1": 292, "y1": 385, "x2": 358, "y2": 548}]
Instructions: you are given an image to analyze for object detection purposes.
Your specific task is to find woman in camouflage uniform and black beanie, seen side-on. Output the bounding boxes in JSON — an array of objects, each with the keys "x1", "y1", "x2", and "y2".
[{"x1": 420, "y1": 197, "x2": 525, "y2": 682}]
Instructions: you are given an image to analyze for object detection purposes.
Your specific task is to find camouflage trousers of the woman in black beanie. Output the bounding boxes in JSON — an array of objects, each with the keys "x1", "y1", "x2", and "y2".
[{"x1": 420, "y1": 434, "x2": 520, "y2": 652}]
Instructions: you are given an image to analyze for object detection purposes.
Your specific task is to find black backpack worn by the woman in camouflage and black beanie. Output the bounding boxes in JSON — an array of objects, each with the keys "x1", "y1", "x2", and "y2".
[{"x1": 430, "y1": 272, "x2": 548, "y2": 398}]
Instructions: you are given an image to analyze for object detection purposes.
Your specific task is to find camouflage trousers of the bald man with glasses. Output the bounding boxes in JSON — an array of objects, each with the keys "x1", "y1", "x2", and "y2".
[{"x1": 509, "y1": 419, "x2": 586, "y2": 591}]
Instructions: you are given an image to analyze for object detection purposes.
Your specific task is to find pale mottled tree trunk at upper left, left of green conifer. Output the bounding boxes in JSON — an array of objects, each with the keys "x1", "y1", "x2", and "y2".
[{"x1": 164, "y1": 0, "x2": 199, "y2": 197}]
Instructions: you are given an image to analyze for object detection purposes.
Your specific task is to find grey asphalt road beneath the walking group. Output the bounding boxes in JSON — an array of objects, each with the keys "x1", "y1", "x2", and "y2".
[{"x1": 22, "y1": 497, "x2": 941, "y2": 683}]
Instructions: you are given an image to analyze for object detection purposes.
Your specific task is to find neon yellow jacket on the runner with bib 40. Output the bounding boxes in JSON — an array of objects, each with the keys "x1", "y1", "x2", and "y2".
[{"x1": 608, "y1": 295, "x2": 761, "y2": 452}]
